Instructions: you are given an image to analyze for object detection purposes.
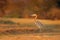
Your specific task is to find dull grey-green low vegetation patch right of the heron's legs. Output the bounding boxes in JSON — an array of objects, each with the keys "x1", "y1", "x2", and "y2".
[{"x1": 44, "y1": 25, "x2": 60, "y2": 33}]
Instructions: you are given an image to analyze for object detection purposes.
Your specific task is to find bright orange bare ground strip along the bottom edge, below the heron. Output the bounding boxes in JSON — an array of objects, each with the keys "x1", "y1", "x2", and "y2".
[{"x1": 0, "y1": 34, "x2": 60, "y2": 40}]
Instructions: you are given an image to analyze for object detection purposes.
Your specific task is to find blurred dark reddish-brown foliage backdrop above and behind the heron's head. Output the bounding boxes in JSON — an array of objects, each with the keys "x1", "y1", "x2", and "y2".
[{"x1": 0, "y1": 0, "x2": 60, "y2": 20}]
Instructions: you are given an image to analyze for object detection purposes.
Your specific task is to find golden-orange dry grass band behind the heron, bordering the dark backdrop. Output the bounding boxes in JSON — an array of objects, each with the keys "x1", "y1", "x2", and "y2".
[{"x1": 0, "y1": 18, "x2": 60, "y2": 24}]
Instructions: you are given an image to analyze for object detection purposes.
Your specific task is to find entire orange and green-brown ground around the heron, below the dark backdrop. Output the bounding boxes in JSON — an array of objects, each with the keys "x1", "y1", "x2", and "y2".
[{"x1": 0, "y1": 18, "x2": 60, "y2": 40}]
